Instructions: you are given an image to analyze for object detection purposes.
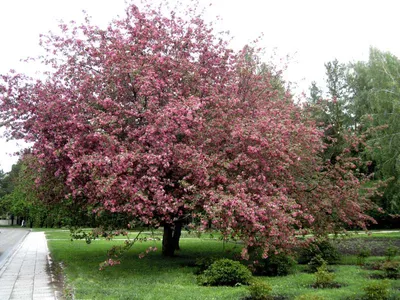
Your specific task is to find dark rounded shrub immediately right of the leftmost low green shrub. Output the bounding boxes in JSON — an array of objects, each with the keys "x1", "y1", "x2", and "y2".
[{"x1": 254, "y1": 253, "x2": 296, "y2": 276}]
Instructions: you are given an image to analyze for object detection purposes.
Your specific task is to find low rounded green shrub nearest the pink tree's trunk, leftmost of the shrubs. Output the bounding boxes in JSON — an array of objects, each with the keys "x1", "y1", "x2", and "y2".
[{"x1": 198, "y1": 258, "x2": 252, "y2": 286}]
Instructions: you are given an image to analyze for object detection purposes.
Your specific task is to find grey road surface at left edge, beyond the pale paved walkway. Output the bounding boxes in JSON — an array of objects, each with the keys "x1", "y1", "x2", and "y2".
[{"x1": 0, "y1": 227, "x2": 30, "y2": 270}]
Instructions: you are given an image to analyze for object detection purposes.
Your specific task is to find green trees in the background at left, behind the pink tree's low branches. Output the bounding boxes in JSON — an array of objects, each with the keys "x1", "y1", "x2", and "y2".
[{"x1": 0, "y1": 154, "x2": 139, "y2": 228}]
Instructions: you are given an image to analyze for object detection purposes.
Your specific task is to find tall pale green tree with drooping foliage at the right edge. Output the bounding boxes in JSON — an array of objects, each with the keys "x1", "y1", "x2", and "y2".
[{"x1": 348, "y1": 48, "x2": 400, "y2": 213}]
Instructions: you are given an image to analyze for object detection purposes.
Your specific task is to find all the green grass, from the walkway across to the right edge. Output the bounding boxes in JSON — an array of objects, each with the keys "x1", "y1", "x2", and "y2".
[{"x1": 46, "y1": 229, "x2": 400, "y2": 300}]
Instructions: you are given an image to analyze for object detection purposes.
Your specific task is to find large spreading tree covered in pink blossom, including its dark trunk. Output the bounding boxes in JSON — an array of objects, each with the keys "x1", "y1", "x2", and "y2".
[{"x1": 0, "y1": 1, "x2": 376, "y2": 255}]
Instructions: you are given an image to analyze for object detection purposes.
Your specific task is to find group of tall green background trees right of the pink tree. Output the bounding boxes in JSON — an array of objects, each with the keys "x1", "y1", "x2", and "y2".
[{"x1": 307, "y1": 48, "x2": 400, "y2": 227}]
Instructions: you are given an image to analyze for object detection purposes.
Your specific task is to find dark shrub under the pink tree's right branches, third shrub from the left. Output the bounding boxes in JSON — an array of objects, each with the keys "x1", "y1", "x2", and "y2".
[{"x1": 298, "y1": 239, "x2": 340, "y2": 264}]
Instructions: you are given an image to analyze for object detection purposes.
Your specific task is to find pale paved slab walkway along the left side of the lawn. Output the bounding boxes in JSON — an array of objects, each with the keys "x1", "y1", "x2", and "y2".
[{"x1": 0, "y1": 232, "x2": 56, "y2": 300}]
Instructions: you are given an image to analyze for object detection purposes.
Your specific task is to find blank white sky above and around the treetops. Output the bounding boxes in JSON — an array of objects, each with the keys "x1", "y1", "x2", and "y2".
[{"x1": 0, "y1": 0, "x2": 400, "y2": 171}]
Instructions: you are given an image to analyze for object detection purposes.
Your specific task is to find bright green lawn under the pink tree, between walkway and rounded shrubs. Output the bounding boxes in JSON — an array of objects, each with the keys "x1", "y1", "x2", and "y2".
[{"x1": 46, "y1": 231, "x2": 246, "y2": 299}]
